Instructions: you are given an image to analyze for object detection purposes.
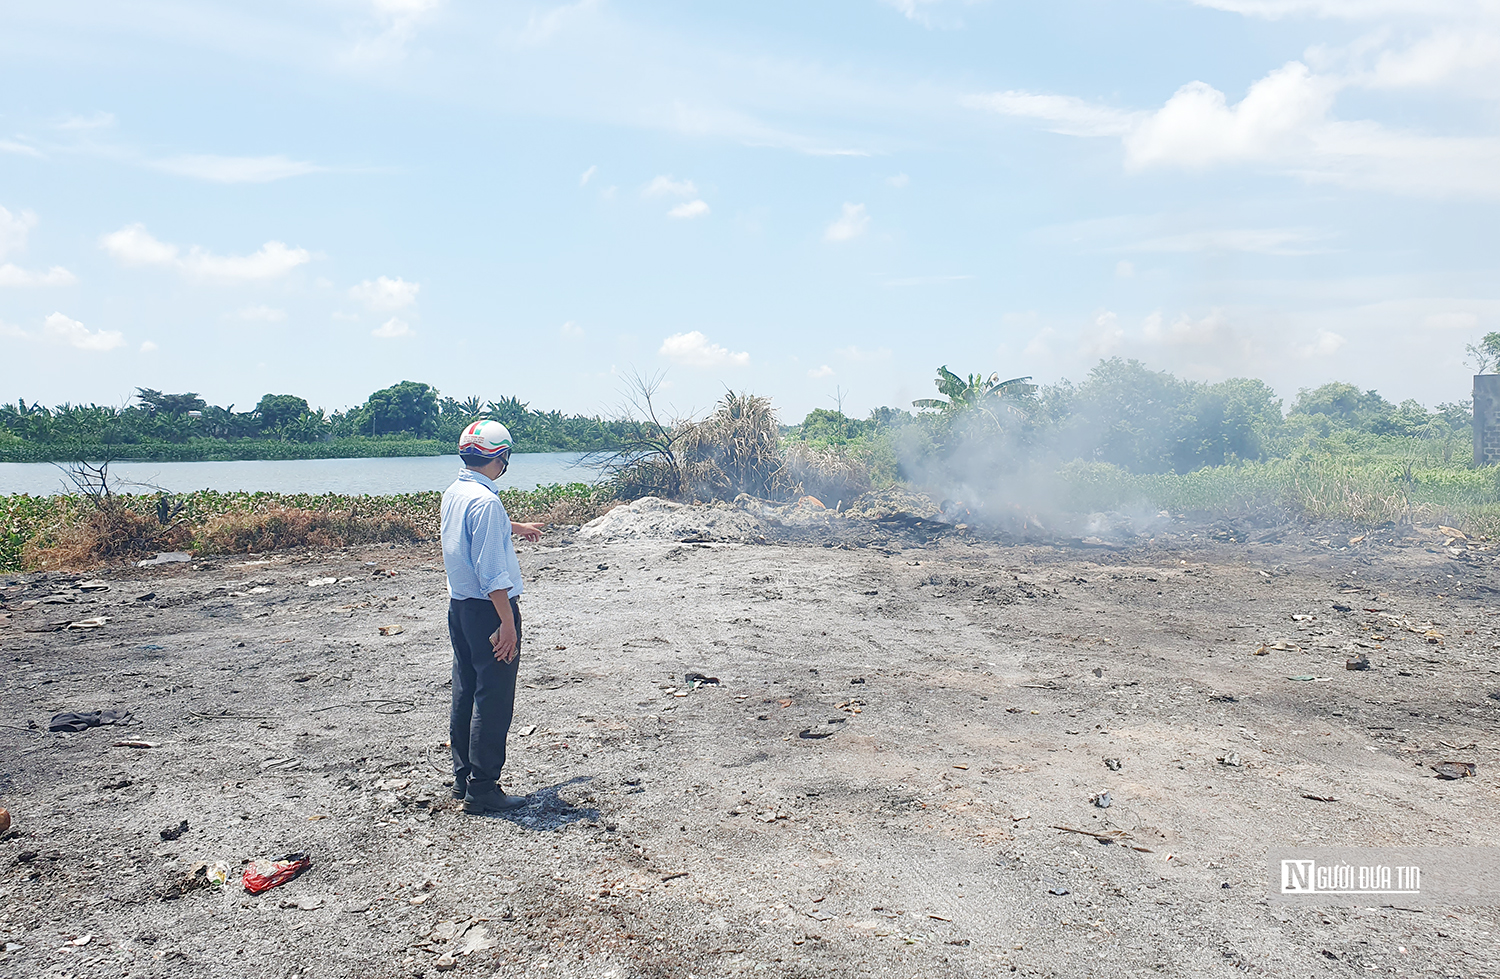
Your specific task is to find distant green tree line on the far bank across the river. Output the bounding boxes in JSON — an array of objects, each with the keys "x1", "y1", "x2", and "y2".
[{"x1": 0, "y1": 381, "x2": 629, "y2": 462}]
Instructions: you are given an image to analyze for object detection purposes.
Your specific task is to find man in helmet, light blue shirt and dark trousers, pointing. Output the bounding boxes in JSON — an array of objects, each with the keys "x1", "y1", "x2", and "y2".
[{"x1": 443, "y1": 421, "x2": 542, "y2": 816}]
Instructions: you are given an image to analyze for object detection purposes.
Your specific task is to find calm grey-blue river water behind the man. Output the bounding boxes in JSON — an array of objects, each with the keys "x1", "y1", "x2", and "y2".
[{"x1": 0, "y1": 453, "x2": 599, "y2": 496}]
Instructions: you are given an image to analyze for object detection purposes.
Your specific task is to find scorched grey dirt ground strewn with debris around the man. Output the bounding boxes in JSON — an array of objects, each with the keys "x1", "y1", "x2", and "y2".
[{"x1": 0, "y1": 503, "x2": 1500, "y2": 979}]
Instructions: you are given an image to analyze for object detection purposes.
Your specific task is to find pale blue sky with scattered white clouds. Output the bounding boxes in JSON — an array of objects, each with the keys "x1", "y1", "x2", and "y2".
[{"x1": 0, "y1": 0, "x2": 1500, "y2": 421}]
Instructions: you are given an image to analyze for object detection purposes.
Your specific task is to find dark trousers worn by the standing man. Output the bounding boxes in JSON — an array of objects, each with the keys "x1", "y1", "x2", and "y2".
[{"x1": 449, "y1": 598, "x2": 521, "y2": 793}]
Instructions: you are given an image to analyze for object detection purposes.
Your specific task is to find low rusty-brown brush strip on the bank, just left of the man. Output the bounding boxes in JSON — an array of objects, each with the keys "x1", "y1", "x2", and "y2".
[{"x1": 198, "y1": 507, "x2": 422, "y2": 555}]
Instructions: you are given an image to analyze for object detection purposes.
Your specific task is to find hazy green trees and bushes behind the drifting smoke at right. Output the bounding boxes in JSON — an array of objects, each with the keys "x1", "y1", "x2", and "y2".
[{"x1": 786, "y1": 357, "x2": 1472, "y2": 474}]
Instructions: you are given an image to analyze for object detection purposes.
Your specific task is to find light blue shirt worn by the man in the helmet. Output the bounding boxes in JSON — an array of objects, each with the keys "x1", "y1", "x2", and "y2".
[{"x1": 443, "y1": 469, "x2": 521, "y2": 598}]
